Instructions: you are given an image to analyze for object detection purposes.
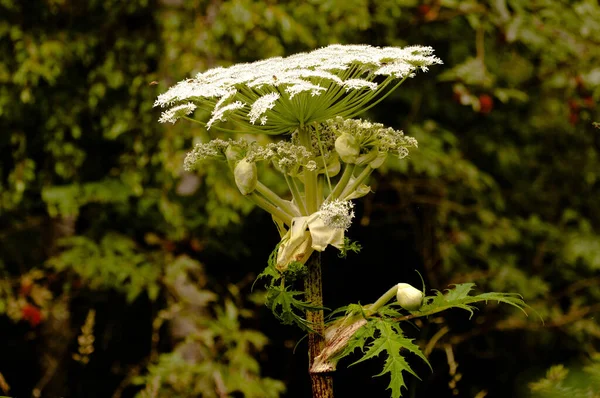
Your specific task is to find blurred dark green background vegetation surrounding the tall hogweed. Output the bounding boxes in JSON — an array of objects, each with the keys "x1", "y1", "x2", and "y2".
[{"x1": 0, "y1": 0, "x2": 600, "y2": 397}]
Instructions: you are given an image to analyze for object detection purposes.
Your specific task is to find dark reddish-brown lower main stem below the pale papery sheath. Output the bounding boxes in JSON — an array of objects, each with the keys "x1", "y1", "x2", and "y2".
[{"x1": 304, "y1": 253, "x2": 333, "y2": 398}]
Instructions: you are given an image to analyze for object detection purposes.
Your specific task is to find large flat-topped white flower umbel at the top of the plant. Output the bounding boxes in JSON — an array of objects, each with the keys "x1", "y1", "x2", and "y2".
[{"x1": 155, "y1": 44, "x2": 442, "y2": 134}]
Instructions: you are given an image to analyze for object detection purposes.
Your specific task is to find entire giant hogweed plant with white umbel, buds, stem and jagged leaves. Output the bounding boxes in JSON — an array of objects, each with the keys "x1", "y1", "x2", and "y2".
[{"x1": 155, "y1": 45, "x2": 525, "y2": 398}]
